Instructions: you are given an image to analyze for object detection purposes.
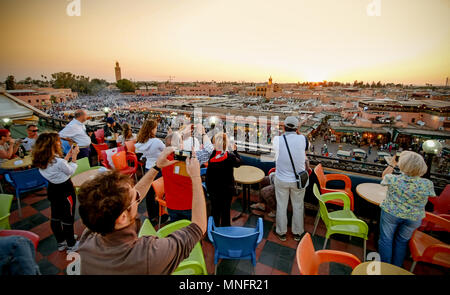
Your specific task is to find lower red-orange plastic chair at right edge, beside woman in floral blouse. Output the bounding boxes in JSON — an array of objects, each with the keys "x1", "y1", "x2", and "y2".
[{"x1": 409, "y1": 212, "x2": 450, "y2": 272}]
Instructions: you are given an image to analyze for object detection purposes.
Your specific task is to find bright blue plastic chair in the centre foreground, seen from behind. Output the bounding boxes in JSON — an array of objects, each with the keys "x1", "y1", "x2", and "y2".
[{"x1": 208, "y1": 216, "x2": 264, "y2": 271}]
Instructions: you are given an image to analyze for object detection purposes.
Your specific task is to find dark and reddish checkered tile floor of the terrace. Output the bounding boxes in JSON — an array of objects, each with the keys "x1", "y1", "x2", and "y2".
[{"x1": 3, "y1": 185, "x2": 449, "y2": 275}]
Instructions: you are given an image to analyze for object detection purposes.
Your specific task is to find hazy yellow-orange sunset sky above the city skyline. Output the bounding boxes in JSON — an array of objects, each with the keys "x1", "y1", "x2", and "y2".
[{"x1": 0, "y1": 0, "x2": 450, "y2": 85}]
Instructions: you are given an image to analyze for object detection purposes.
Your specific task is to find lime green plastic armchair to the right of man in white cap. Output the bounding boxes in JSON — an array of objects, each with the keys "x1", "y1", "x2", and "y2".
[{"x1": 313, "y1": 184, "x2": 369, "y2": 260}]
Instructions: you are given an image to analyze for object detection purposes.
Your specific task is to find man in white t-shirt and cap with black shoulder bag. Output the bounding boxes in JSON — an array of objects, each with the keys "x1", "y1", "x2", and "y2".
[{"x1": 273, "y1": 117, "x2": 309, "y2": 241}]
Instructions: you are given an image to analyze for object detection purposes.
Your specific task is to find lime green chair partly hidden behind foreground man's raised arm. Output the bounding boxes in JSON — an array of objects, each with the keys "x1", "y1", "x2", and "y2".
[{"x1": 138, "y1": 219, "x2": 208, "y2": 275}]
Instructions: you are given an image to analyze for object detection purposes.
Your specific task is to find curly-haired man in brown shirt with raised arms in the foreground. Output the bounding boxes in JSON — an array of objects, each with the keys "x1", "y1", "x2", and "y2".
[{"x1": 78, "y1": 147, "x2": 207, "y2": 275}]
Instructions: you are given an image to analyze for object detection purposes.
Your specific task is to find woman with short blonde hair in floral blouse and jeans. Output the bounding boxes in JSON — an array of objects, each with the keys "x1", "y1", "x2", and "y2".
[{"x1": 378, "y1": 151, "x2": 436, "y2": 267}]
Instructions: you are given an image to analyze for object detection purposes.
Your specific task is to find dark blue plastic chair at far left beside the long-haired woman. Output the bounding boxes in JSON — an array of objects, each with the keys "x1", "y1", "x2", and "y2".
[{"x1": 5, "y1": 168, "x2": 48, "y2": 217}]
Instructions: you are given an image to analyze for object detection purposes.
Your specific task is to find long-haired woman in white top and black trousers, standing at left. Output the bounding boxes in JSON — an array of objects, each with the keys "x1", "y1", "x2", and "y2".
[{"x1": 32, "y1": 133, "x2": 80, "y2": 252}]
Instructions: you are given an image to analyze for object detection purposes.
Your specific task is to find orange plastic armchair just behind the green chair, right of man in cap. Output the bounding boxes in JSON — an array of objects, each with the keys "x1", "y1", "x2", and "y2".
[{"x1": 308, "y1": 164, "x2": 354, "y2": 232}]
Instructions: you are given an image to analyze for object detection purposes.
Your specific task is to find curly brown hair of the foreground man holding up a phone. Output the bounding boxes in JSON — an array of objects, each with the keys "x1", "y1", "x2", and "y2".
[{"x1": 78, "y1": 170, "x2": 132, "y2": 235}]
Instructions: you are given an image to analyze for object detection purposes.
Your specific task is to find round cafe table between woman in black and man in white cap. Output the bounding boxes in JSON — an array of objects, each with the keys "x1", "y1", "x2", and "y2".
[{"x1": 233, "y1": 165, "x2": 265, "y2": 221}]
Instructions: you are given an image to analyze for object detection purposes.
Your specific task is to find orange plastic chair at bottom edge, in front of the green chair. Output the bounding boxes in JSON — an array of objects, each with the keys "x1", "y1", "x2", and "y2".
[{"x1": 296, "y1": 233, "x2": 361, "y2": 275}]
